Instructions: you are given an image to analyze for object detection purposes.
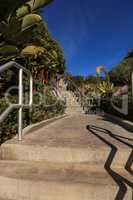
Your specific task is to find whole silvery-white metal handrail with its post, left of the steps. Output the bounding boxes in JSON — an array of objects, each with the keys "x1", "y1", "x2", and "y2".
[{"x1": 0, "y1": 61, "x2": 33, "y2": 141}]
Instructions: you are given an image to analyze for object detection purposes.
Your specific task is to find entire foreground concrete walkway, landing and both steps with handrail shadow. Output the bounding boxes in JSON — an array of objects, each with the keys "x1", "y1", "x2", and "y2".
[{"x1": 0, "y1": 113, "x2": 133, "y2": 200}]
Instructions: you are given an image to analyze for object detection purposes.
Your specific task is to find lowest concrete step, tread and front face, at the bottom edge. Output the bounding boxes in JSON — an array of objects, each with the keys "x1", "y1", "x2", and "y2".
[{"x1": 0, "y1": 161, "x2": 132, "y2": 200}]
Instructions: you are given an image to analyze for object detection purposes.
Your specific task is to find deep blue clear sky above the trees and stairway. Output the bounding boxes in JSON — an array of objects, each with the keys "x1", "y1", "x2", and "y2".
[{"x1": 43, "y1": 0, "x2": 133, "y2": 76}]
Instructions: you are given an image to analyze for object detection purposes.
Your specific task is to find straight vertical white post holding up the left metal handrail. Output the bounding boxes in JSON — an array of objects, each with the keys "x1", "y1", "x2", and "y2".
[{"x1": 18, "y1": 69, "x2": 23, "y2": 141}]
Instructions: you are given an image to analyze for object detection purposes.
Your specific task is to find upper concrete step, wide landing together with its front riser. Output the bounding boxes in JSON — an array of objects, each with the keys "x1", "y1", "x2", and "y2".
[{"x1": 1, "y1": 114, "x2": 132, "y2": 168}]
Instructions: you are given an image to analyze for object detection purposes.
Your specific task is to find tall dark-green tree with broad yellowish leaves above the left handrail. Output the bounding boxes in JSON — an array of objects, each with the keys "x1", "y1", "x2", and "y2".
[{"x1": 0, "y1": 0, "x2": 65, "y2": 81}]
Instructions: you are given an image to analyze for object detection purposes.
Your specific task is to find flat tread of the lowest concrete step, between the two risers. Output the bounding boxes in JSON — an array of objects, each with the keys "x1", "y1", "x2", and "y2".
[{"x1": 0, "y1": 161, "x2": 129, "y2": 185}]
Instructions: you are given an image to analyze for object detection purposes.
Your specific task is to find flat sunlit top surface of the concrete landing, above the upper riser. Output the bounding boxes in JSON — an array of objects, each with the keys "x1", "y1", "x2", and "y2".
[{"x1": 4, "y1": 114, "x2": 133, "y2": 150}]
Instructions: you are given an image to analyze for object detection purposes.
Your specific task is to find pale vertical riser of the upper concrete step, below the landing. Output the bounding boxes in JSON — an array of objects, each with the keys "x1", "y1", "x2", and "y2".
[{"x1": 1, "y1": 141, "x2": 130, "y2": 167}]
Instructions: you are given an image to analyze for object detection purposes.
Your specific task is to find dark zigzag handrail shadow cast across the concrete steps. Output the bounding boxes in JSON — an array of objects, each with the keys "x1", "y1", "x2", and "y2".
[{"x1": 87, "y1": 125, "x2": 133, "y2": 200}]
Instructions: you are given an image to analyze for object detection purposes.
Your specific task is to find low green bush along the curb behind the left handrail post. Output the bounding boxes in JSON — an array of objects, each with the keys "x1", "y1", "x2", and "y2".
[{"x1": 0, "y1": 99, "x2": 65, "y2": 144}]
